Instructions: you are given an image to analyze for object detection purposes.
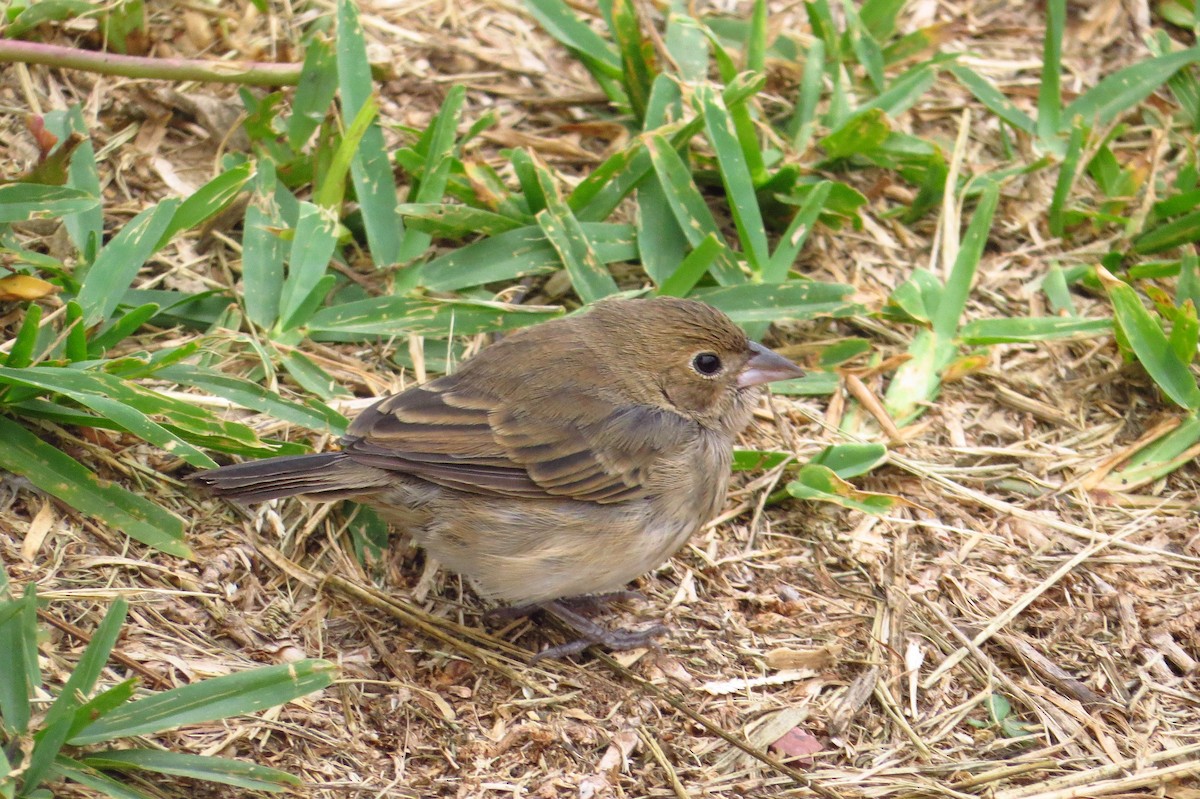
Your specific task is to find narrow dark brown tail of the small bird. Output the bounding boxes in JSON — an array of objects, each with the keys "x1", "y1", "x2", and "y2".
[{"x1": 188, "y1": 452, "x2": 388, "y2": 503}]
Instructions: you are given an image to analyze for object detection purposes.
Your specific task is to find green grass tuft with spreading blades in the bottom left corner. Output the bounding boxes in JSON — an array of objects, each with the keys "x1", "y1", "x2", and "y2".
[{"x1": 0, "y1": 569, "x2": 334, "y2": 799}]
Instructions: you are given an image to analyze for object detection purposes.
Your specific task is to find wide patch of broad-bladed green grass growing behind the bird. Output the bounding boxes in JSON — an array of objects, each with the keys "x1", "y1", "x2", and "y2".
[{"x1": 0, "y1": 0, "x2": 1200, "y2": 573}]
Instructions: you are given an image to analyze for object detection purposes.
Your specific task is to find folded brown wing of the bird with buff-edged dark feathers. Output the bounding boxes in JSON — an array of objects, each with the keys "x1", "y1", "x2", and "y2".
[{"x1": 346, "y1": 376, "x2": 690, "y2": 503}]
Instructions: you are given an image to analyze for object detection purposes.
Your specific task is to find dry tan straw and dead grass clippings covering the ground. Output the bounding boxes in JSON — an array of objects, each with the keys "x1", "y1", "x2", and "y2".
[{"x1": 0, "y1": 0, "x2": 1200, "y2": 799}]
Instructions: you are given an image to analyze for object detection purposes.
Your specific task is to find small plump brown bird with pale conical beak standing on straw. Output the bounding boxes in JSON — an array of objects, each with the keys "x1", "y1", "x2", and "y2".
[{"x1": 194, "y1": 298, "x2": 803, "y2": 656}]
